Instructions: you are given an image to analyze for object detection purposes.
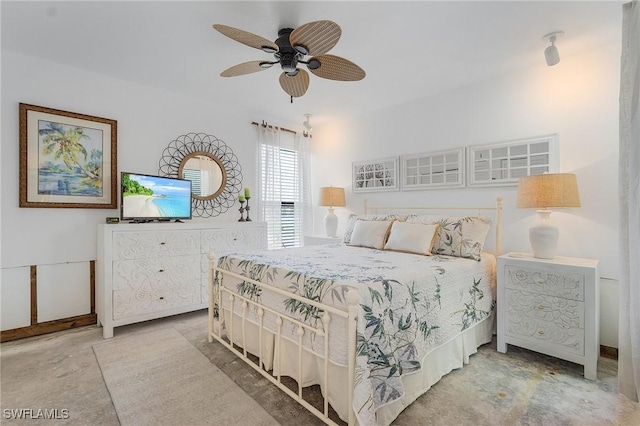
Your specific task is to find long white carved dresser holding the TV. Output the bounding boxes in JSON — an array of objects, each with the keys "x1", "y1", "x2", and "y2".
[{"x1": 96, "y1": 222, "x2": 267, "y2": 339}]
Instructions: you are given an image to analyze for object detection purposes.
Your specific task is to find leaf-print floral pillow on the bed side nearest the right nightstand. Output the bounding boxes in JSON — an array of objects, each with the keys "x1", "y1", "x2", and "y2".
[{"x1": 407, "y1": 216, "x2": 491, "y2": 261}]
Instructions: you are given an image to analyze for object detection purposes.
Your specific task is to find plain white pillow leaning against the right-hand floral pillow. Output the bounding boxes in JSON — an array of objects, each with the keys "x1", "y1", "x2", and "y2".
[{"x1": 384, "y1": 222, "x2": 439, "y2": 256}]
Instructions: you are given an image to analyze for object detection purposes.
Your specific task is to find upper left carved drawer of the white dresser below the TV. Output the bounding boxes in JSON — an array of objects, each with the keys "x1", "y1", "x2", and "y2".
[{"x1": 113, "y1": 231, "x2": 200, "y2": 260}]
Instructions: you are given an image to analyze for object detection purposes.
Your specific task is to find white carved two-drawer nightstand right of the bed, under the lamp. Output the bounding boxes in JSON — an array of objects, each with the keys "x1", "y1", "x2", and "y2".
[{"x1": 498, "y1": 253, "x2": 600, "y2": 380}]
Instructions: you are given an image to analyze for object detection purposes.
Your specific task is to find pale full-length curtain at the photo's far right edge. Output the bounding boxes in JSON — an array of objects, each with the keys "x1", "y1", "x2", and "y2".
[{"x1": 618, "y1": 0, "x2": 640, "y2": 401}]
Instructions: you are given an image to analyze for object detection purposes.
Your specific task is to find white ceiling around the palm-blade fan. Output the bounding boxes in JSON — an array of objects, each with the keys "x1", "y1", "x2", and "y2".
[{"x1": 0, "y1": 0, "x2": 624, "y2": 123}]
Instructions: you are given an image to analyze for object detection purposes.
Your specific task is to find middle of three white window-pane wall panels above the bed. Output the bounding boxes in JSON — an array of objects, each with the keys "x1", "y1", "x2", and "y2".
[{"x1": 401, "y1": 148, "x2": 462, "y2": 190}]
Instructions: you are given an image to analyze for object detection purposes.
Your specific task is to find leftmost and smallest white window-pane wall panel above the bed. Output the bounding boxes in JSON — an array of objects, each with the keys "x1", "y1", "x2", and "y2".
[{"x1": 352, "y1": 157, "x2": 398, "y2": 192}]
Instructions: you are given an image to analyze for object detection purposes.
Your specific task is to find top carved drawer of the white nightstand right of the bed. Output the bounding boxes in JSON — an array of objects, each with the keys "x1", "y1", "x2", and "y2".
[{"x1": 504, "y1": 265, "x2": 584, "y2": 301}]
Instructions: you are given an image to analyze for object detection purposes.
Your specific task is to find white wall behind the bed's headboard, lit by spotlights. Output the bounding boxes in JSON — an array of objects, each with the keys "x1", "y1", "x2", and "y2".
[{"x1": 312, "y1": 45, "x2": 620, "y2": 346}]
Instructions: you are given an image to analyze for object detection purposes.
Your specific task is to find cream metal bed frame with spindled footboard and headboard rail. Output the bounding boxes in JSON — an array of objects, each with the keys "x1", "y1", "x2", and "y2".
[{"x1": 208, "y1": 197, "x2": 502, "y2": 426}]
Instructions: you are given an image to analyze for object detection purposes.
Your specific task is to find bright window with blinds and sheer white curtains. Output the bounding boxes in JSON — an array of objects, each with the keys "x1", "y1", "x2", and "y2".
[{"x1": 257, "y1": 126, "x2": 313, "y2": 249}]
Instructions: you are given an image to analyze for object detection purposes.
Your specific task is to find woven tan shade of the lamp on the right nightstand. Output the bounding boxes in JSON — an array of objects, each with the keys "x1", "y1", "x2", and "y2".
[{"x1": 517, "y1": 173, "x2": 580, "y2": 209}]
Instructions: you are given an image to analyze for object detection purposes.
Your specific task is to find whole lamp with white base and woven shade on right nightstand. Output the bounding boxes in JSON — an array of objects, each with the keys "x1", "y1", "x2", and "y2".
[{"x1": 517, "y1": 173, "x2": 580, "y2": 259}]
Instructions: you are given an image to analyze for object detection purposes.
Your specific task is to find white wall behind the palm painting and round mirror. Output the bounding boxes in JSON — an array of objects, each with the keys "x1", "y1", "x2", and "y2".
[{"x1": 0, "y1": 50, "x2": 287, "y2": 329}]
